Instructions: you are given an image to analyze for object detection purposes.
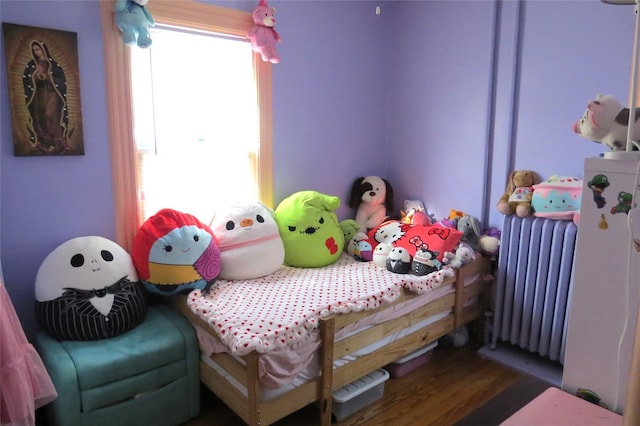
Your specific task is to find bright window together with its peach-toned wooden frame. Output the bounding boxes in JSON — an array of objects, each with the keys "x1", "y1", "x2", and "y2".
[{"x1": 101, "y1": 1, "x2": 273, "y2": 249}]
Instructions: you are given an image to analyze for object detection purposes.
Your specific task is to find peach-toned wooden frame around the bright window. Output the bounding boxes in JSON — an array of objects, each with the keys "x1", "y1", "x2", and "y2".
[{"x1": 100, "y1": 0, "x2": 273, "y2": 251}]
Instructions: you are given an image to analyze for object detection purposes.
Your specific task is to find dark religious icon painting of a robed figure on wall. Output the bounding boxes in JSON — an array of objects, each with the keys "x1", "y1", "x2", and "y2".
[{"x1": 2, "y1": 22, "x2": 84, "y2": 156}]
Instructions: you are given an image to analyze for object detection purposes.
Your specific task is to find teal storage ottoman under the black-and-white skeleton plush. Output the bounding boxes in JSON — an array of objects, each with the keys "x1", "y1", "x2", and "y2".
[{"x1": 34, "y1": 304, "x2": 200, "y2": 426}]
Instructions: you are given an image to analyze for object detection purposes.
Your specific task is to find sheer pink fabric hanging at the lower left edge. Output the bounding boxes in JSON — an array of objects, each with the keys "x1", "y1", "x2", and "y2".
[{"x1": 0, "y1": 281, "x2": 58, "y2": 426}]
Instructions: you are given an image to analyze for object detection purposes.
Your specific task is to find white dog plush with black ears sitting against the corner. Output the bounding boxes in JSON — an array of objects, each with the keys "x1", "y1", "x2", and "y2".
[{"x1": 349, "y1": 176, "x2": 393, "y2": 232}]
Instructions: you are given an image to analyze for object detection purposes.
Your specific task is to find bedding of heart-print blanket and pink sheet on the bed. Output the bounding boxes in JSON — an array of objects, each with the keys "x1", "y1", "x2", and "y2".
[{"x1": 187, "y1": 255, "x2": 455, "y2": 388}]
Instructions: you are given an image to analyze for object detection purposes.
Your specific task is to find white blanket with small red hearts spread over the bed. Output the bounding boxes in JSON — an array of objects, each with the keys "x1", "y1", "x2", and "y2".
[{"x1": 187, "y1": 254, "x2": 455, "y2": 356}]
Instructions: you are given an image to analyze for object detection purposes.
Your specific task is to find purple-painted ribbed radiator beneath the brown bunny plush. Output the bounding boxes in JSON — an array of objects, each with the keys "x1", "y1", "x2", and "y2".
[{"x1": 491, "y1": 215, "x2": 577, "y2": 364}]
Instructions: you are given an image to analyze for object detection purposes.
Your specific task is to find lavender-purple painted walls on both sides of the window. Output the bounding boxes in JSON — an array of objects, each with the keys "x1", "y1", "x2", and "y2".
[{"x1": 0, "y1": 0, "x2": 633, "y2": 340}]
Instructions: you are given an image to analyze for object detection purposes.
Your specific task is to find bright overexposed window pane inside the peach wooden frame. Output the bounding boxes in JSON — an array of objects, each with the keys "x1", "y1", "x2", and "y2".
[{"x1": 131, "y1": 27, "x2": 260, "y2": 223}]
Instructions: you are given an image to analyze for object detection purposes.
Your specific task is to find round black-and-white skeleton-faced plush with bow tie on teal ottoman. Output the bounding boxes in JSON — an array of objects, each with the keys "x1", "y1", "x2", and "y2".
[{"x1": 35, "y1": 236, "x2": 147, "y2": 340}]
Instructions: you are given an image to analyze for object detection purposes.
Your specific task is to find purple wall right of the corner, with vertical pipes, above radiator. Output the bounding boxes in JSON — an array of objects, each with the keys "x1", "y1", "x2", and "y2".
[{"x1": 387, "y1": 1, "x2": 634, "y2": 230}]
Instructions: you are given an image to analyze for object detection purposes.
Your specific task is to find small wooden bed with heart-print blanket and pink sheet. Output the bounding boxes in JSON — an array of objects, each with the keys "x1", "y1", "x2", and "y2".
[{"x1": 168, "y1": 254, "x2": 493, "y2": 425}]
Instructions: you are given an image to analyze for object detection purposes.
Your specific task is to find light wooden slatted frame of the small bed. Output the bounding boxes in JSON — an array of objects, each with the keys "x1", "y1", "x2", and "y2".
[{"x1": 169, "y1": 258, "x2": 492, "y2": 426}]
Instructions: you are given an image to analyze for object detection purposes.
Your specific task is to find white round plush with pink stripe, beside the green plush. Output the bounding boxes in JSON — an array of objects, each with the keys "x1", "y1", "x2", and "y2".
[{"x1": 211, "y1": 201, "x2": 284, "y2": 280}]
